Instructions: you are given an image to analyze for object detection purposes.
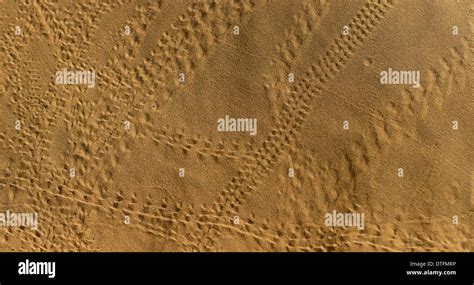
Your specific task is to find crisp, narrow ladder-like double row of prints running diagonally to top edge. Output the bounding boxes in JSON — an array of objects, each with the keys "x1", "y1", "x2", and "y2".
[{"x1": 215, "y1": 1, "x2": 392, "y2": 212}]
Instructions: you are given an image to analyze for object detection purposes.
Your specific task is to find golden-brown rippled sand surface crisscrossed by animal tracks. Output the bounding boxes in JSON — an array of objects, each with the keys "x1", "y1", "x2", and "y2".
[{"x1": 0, "y1": 0, "x2": 474, "y2": 251}]
